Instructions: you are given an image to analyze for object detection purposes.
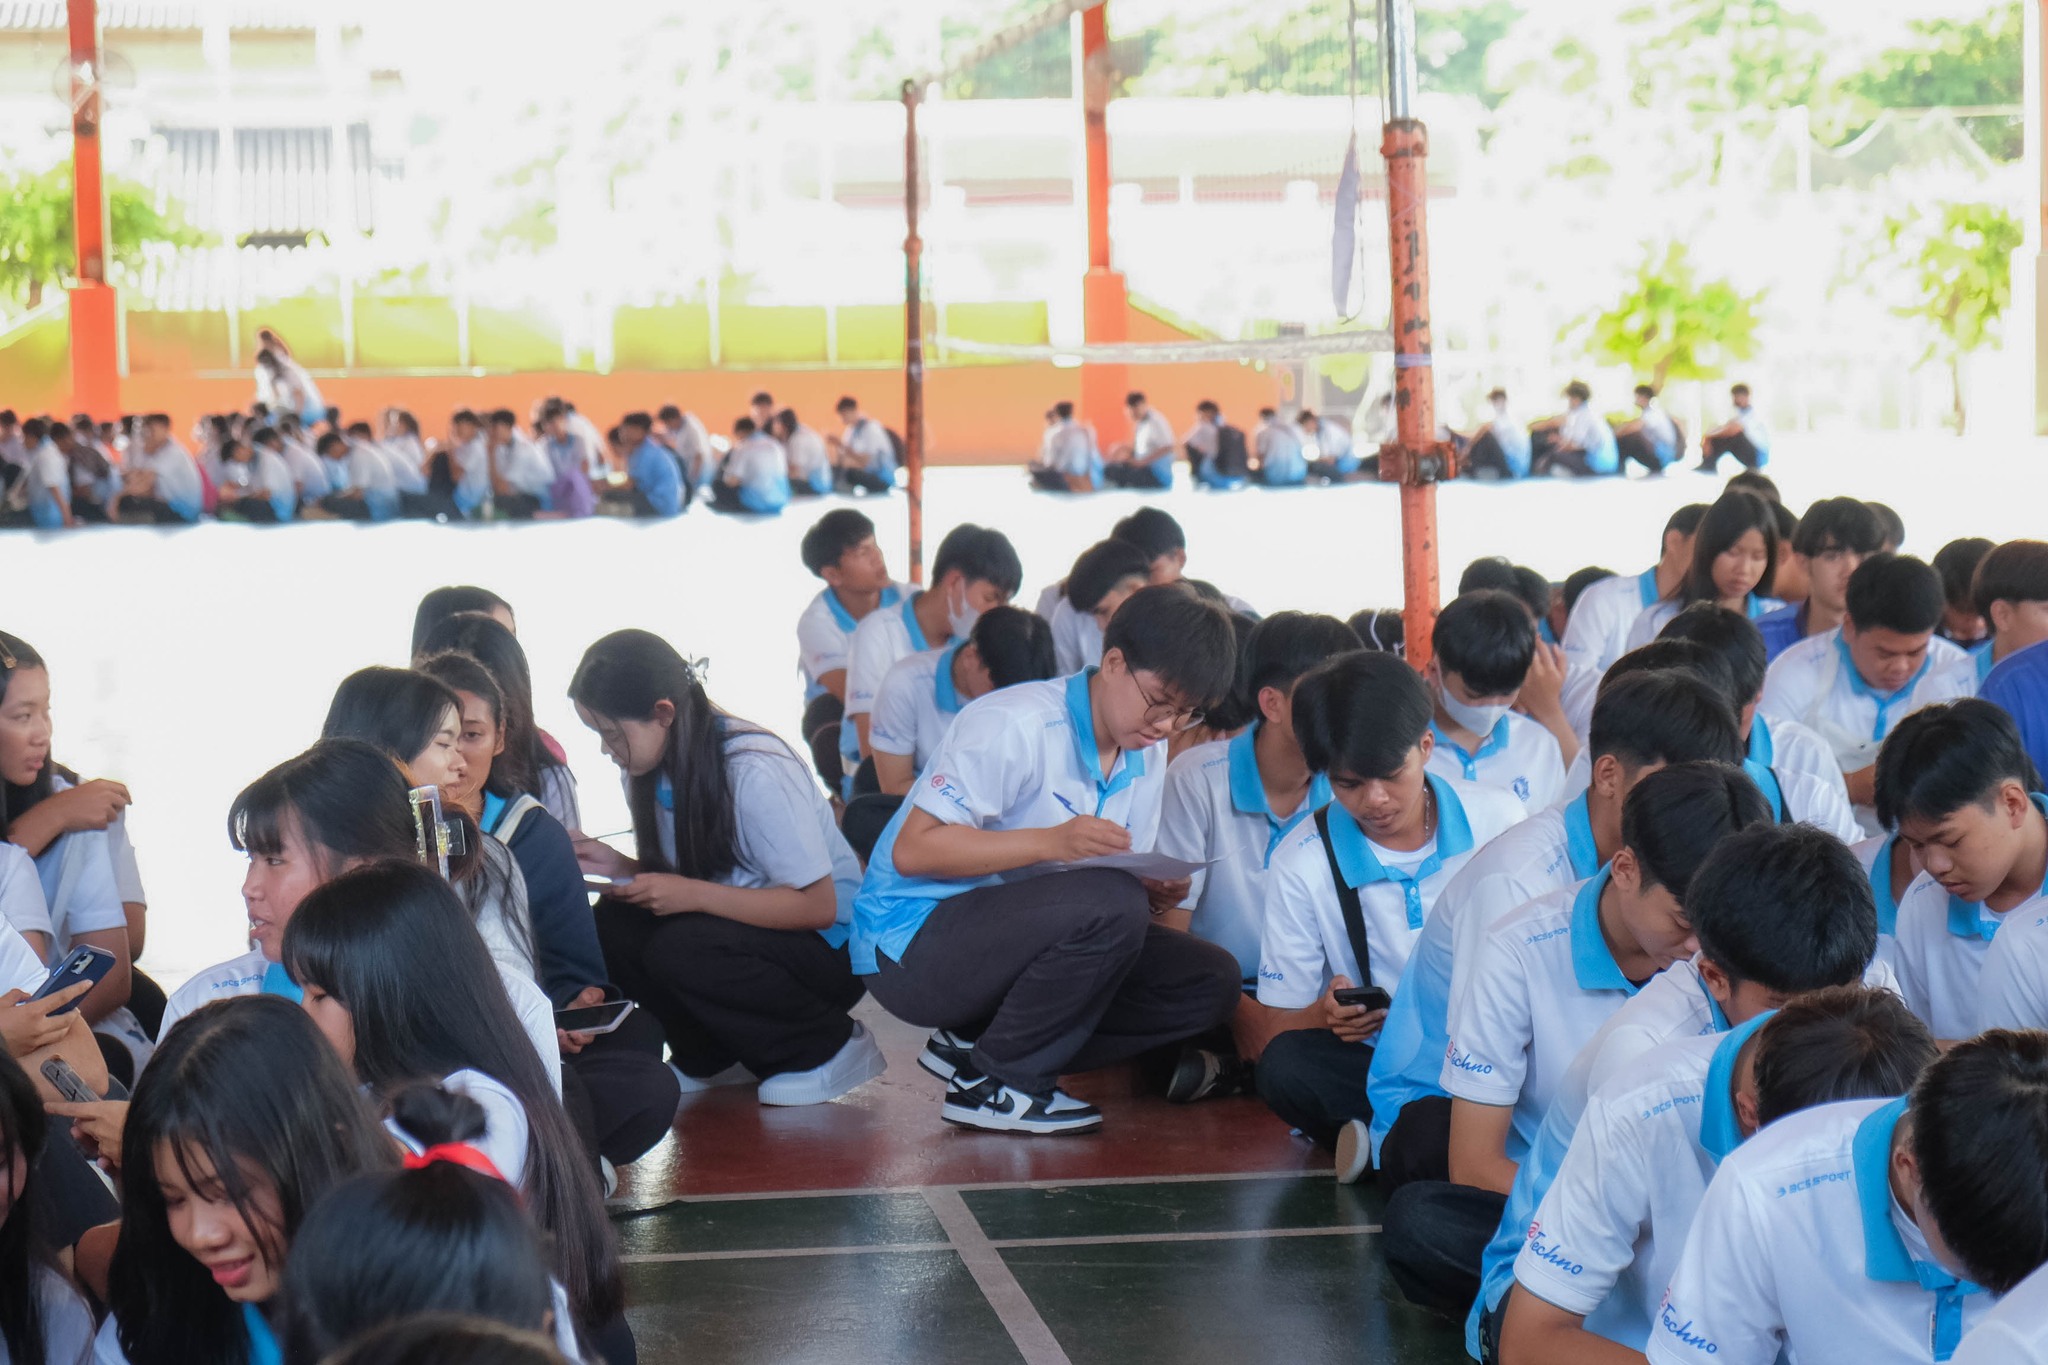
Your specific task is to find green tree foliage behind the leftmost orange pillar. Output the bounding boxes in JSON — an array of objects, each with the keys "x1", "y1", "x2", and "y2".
[{"x1": 0, "y1": 162, "x2": 205, "y2": 309}]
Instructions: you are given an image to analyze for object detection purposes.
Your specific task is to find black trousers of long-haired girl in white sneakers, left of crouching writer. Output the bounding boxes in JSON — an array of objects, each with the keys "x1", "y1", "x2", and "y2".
[{"x1": 596, "y1": 898, "x2": 864, "y2": 1081}]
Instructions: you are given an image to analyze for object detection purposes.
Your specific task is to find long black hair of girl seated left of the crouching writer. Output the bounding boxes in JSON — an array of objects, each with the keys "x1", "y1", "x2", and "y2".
[{"x1": 569, "y1": 630, "x2": 797, "y2": 882}]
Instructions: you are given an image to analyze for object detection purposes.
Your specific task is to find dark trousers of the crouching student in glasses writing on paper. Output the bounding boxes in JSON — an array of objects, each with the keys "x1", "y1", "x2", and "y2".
[{"x1": 866, "y1": 868, "x2": 1239, "y2": 1095}]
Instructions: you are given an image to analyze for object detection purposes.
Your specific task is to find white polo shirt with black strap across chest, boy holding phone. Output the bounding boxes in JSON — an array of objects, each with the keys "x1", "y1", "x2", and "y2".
[{"x1": 1260, "y1": 774, "x2": 1522, "y2": 1009}]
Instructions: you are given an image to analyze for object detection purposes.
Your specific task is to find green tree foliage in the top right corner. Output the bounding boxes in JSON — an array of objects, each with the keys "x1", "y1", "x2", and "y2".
[{"x1": 1843, "y1": 4, "x2": 2025, "y2": 162}]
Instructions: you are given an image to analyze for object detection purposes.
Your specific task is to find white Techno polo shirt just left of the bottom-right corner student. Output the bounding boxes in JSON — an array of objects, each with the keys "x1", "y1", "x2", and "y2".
[{"x1": 1481, "y1": 1013, "x2": 1769, "y2": 1351}]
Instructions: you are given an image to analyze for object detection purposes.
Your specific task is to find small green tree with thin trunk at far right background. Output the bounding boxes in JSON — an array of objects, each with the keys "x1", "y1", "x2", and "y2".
[{"x1": 1884, "y1": 203, "x2": 2025, "y2": 432}]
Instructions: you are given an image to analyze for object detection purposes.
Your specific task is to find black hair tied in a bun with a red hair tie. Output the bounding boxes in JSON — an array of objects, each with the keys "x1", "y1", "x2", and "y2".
[{"x1": 283, "y1": 1085, "x2": 553, "y2": 1365}]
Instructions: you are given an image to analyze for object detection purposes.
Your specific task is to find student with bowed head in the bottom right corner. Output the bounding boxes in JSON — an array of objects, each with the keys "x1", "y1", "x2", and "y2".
[{"x1": 1645, "y1": 1029, "x2": 2048, "y2": 1365}]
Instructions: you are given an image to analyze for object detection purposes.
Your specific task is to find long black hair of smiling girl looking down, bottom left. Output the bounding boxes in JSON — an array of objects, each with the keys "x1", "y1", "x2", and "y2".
[{"x1": 106, "y1": 995, "x2": 397, "y2": 1365}]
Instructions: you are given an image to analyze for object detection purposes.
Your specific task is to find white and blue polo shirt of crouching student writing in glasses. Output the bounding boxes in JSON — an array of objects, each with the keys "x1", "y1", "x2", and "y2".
[{"x1": 852, "y1": 667, "x2": 1165, "y2": 976}]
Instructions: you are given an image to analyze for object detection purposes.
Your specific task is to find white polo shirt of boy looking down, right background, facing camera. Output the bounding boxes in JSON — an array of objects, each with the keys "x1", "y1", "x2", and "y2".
[{"x1": 1763, "y1": 628, "x2": 1976, "y2": 835}]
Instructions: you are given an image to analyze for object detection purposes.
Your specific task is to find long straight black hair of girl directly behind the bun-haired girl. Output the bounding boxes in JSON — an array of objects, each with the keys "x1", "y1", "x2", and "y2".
[{"x1": 283, "y1": 862, "x2": 623, "y2": 1326}]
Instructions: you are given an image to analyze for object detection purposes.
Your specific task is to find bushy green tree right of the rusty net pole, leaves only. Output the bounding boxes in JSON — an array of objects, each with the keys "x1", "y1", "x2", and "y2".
[{"x1": 1565, "y1": 241, "x2": 1763, "y2": 389}]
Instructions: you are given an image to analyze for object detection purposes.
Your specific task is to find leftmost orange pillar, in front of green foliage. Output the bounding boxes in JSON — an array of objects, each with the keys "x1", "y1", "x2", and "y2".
[{"x1": 70, "y1": 0, "x2": 121, "y2": 420}]
